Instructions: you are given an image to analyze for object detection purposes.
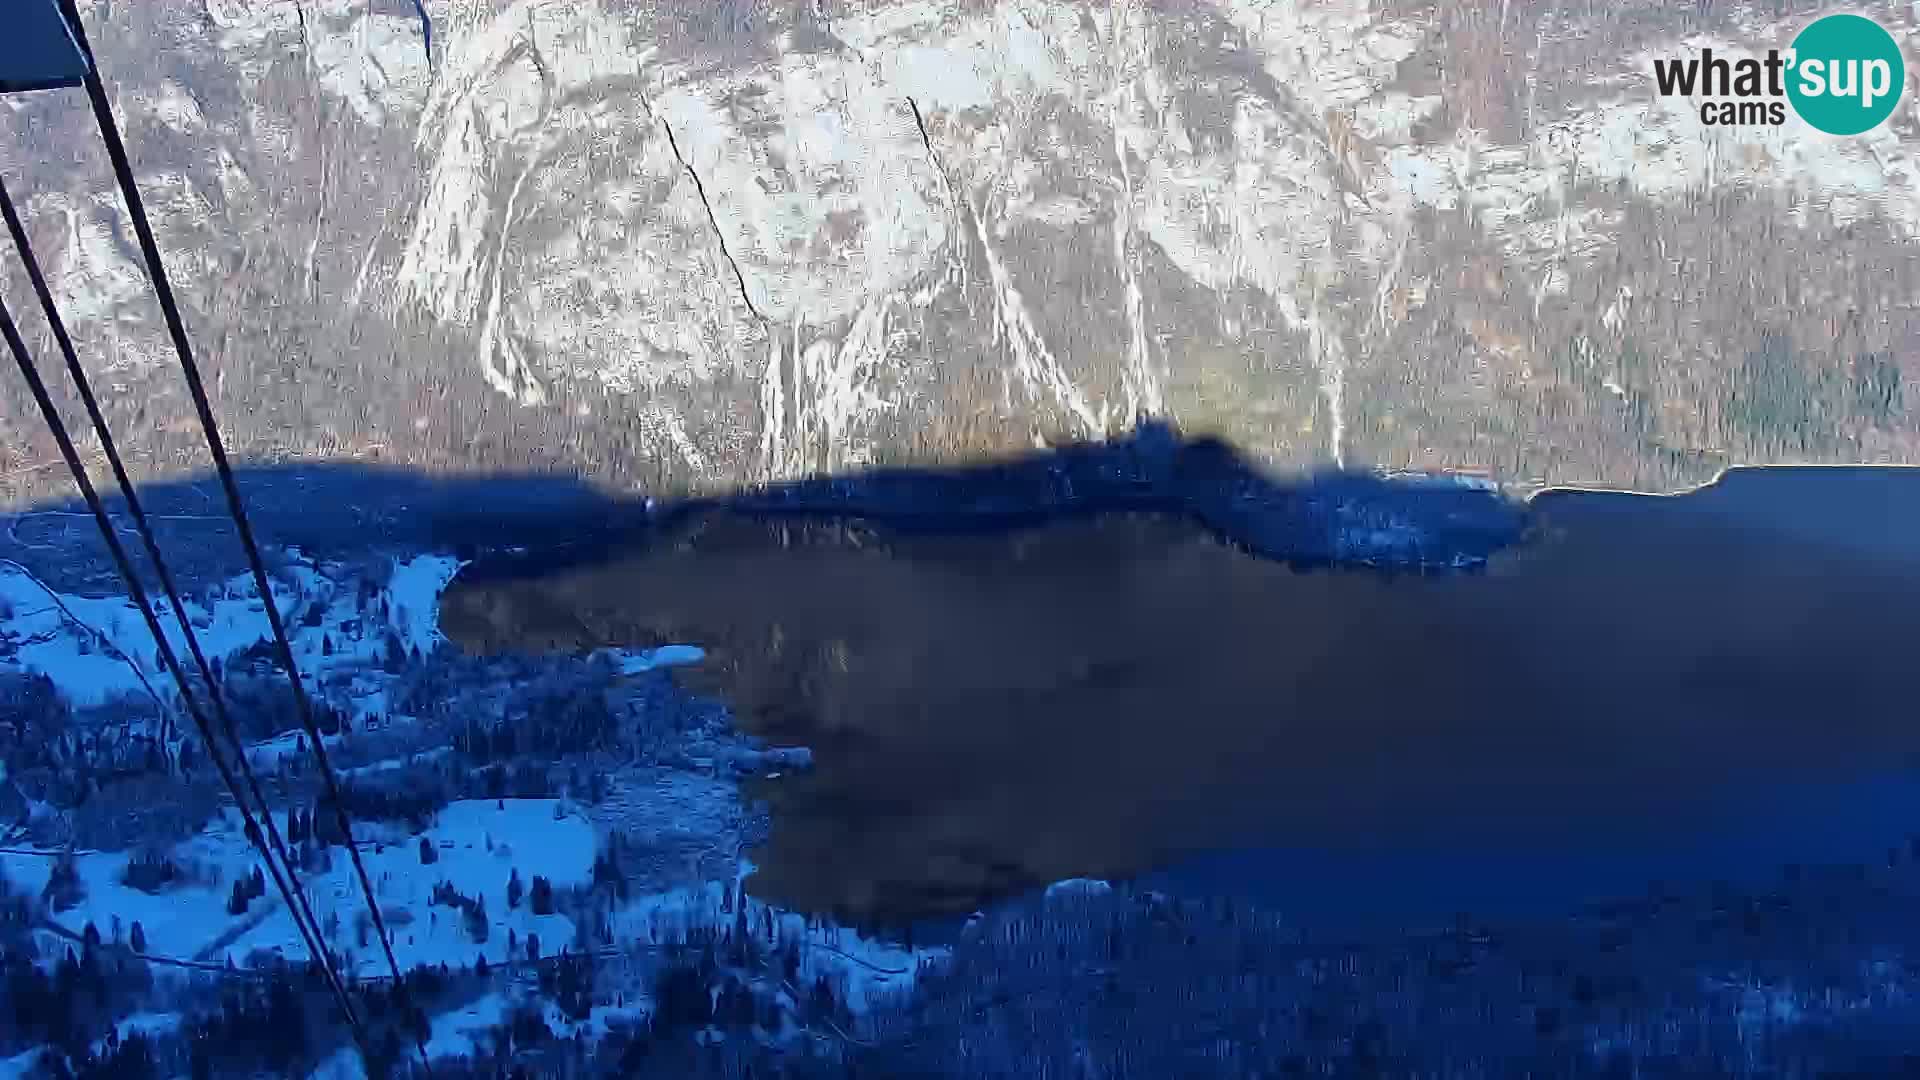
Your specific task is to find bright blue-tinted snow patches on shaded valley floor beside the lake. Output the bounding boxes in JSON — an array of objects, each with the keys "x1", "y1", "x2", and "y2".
[{"x1": 0, "y1": 526, "x2": 943, "y2": 1053}]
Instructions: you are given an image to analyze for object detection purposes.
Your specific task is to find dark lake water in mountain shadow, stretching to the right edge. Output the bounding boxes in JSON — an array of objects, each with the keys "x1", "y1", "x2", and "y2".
[{"x1": 444, "y1": 457, "x2": 1920, "y2": 934}]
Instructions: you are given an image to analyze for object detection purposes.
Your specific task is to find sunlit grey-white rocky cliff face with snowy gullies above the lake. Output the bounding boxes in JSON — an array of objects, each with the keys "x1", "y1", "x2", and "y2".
[{"x1": 0, "y1": 0, "x2": 1920, "y2": 498}]
